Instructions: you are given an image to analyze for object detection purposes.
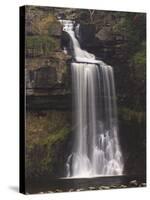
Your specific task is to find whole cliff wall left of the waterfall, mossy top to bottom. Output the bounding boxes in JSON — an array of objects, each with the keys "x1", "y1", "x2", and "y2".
[{"x1": 25, "y1": 6, "x2": 71, "y2": 180}]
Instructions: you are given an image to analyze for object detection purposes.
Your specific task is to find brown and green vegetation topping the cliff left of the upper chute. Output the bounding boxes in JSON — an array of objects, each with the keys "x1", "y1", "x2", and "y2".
[{"x1": 25, "y1": 6, "x2": 61, "y2": 58}]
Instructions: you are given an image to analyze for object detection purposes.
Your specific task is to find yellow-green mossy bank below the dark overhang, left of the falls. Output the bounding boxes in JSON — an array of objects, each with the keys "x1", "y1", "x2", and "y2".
[{"x1": 26, "y1": 111, "x2": 70, "y2": 177}]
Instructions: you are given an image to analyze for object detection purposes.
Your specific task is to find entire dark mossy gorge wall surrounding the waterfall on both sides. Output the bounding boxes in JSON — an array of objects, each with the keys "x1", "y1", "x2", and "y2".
[{"x1": 25, "y1": 6, "x2": 146, "y2": 176}]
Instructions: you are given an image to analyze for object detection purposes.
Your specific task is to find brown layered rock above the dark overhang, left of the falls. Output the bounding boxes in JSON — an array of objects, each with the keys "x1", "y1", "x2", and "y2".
[{"x1": 25, "y1": 6, "x2": 70, "y2": 95}]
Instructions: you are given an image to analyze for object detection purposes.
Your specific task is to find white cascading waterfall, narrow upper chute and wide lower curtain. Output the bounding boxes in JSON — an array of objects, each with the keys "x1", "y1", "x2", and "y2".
[{"x1": 60, "y1": 20, "x2": 123, "y2": 177}]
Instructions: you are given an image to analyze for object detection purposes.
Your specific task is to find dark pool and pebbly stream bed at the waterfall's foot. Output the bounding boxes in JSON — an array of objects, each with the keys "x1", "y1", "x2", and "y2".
[{"x1": 27, "y1": 175, "x2": 146, "y2": 193}]
